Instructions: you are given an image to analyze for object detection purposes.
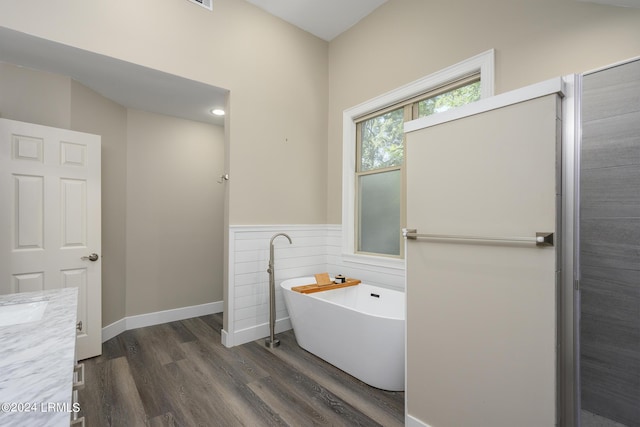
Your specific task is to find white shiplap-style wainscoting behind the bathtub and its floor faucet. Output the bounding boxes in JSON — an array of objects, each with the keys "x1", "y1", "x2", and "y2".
[{"x1": 228, "y1": 224, "x2": 404, "y2": 346}]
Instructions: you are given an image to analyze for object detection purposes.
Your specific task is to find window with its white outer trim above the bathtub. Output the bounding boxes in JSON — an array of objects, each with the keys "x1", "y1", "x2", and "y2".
[{"x1": 343, "y1": 50, "x2": 493, "y2": 268}]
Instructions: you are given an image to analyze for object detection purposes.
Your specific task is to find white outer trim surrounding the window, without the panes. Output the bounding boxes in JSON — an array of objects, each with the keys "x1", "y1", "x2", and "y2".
[{"x1": 342, "y1": 49, "x2": 495, "y2": 269}]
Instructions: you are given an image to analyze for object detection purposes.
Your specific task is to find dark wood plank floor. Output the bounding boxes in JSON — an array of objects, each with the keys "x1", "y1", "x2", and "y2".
[{"x1": 80, "y1": 314, "x2": 404, "y2": 427}]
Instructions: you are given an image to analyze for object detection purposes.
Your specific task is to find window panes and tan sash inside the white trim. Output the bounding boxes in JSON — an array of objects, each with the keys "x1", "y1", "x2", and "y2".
[{"x1": 355, "y1": 75, "x2": 481, "y2": 257}]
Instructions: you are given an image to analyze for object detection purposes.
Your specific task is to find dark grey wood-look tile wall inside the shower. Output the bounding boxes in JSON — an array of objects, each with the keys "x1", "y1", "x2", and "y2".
[{"x1": 580, "y1": 61, "x2": 640, "y2": 426}]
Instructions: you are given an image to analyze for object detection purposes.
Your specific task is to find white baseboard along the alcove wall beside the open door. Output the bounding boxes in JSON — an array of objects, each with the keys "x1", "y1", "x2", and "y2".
[{"x1": 102, "y1": 301, "x2": 224, "y2": 342}]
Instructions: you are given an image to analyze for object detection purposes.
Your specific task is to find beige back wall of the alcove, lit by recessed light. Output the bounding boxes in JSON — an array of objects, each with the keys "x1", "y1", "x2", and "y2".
[{"x1": 126, "y1": 110, "x2": 224, "y2": 316}]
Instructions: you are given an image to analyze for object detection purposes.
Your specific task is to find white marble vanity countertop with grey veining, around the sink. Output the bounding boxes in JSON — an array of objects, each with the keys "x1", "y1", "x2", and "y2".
[{"x1": 0, "y1": 288, "x2": 78, "y2": 427}]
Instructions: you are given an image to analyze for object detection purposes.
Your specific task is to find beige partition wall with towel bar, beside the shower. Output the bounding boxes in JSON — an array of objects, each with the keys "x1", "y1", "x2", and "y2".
[{"x1": 406, "y1": 94, "x2": 559, "y2": 427}]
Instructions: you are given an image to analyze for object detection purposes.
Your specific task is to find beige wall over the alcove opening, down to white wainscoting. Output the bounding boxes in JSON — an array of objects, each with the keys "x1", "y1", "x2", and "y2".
[{"x1": 0, "y1": 0, "x2": 328, "y2": 224}]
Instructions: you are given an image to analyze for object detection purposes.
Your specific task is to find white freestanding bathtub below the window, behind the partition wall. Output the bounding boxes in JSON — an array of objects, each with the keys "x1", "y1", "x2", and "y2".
[{"x1": 280, "y1": 277, "x2": 405, "y2": 391}]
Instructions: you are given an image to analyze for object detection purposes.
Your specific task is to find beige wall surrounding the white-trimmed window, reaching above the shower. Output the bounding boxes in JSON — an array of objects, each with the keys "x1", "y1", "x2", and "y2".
[{"x1": 327, "y1": 0, "x2": 640, "y2": 223}]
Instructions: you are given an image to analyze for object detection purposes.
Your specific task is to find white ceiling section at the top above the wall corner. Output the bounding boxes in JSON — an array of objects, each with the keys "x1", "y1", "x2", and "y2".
[{"x1": 244, "y1": 0, "x2": 387, "y2": 41}]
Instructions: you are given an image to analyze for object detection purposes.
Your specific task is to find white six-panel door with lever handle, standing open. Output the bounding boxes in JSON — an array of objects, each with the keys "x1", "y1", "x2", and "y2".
[{"x1": 0, "y1": 119, "x2": 102, "y2": 359}]
